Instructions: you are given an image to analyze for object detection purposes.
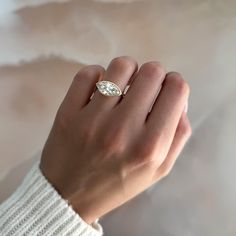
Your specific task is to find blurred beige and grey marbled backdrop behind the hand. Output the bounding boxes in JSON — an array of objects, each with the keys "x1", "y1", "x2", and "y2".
[{"x1": 0, "y1": 0, "x2": 236, "y2": 236}]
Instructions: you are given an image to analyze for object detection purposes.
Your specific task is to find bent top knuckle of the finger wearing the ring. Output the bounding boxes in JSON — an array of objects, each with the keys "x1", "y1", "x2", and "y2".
[{"x1": 111, "y1": 56, "x2": 137, "y2": 70}]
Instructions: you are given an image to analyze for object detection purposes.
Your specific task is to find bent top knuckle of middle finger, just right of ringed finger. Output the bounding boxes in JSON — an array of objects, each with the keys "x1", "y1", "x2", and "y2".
[{"x1": 140, "y1": 62, "x2": 165, "y2": 78}]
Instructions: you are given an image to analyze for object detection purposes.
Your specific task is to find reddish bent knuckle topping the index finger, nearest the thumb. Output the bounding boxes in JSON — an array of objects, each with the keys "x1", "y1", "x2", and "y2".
[{"x1": 166, "y1": 72, "x2": 190, "y2": 95}]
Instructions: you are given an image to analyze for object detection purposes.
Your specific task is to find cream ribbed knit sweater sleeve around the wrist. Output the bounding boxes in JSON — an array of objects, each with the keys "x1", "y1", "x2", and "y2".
[{"x1": 0, "y1": 161, "x2": 103, "y2": 236}]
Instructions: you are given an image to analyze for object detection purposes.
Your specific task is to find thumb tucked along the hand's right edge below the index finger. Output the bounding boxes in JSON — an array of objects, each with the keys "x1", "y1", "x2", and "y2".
[{"x1": 153, "y1": 112, "x2": 192, "y2": 183}]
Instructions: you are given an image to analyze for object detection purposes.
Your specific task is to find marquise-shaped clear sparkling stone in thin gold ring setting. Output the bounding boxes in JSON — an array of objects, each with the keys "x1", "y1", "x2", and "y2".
[{"x1": 96, "y1": 80, "x2": 122, "y2": 96}]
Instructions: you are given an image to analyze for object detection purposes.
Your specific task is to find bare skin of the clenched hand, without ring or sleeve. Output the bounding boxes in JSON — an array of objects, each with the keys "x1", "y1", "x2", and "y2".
[{"x1": 40, "y1": 56, "x2": 192, "y2": 224}]
